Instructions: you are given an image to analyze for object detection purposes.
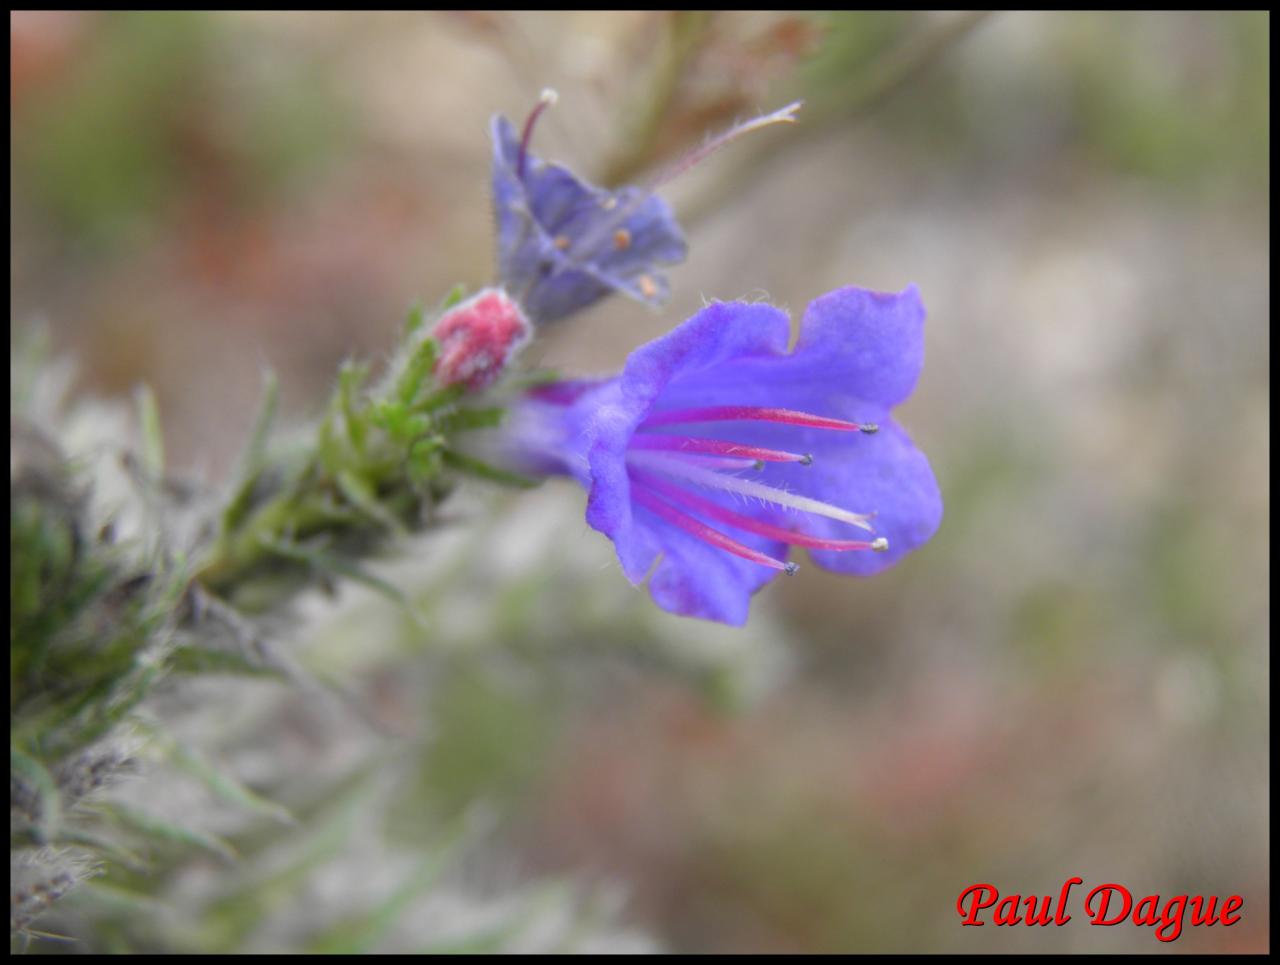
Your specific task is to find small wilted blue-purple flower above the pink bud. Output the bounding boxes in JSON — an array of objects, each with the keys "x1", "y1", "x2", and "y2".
[{"x1": 492, "y1": 95, "x2": 686, "y2": 324}]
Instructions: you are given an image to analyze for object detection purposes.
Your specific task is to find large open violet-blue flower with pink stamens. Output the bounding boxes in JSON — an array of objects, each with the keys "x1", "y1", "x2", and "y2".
[{"x1": 512, "y1": 285, "x2": 942, "y2": 625}]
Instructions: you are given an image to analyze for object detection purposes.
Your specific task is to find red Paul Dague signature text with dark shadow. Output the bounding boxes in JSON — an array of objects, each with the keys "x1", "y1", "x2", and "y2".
[{"x1": 956, "y1": 878, "x2": 1244, "y2": 942}]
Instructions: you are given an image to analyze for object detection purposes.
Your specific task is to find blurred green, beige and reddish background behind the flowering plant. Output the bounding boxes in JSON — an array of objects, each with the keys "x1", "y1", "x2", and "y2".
[{"x1": 10, "y1": 12, "x2": 1270, "y2": 952}]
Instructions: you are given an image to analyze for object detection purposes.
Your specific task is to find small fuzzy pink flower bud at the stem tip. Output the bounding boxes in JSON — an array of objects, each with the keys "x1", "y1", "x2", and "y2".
[{"x1": 431, "y1": 288, "x2": 532, "y2": 390}]
